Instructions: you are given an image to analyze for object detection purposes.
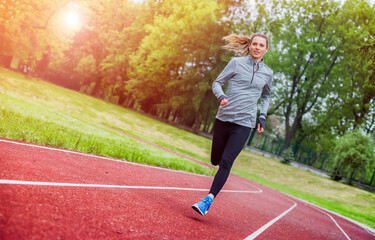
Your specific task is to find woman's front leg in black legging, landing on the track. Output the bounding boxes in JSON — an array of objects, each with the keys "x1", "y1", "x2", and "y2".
[{"x1": 210, "y1": 124, "x2": 251, "y2": 197}]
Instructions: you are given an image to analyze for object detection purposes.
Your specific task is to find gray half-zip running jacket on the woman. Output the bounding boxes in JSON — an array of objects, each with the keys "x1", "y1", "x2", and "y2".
[{"x1": 212, "y1": 55, "x2": 273, "y2": 128}]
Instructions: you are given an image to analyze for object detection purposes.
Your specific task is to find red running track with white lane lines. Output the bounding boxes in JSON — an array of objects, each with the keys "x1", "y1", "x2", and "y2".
[{"x1": 0, "y1": 139, "x2": 375, "y2": 240}]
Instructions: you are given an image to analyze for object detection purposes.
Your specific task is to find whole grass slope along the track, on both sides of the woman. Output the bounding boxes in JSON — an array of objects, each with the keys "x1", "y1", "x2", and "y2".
[{"x1": 0, "y1": 69, "x2": 375, "y2": 231}]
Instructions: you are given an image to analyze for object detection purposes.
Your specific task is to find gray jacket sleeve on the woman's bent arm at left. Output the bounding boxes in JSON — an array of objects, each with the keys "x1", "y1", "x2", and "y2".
[{"x1": 212, "y1": 58, "x2": 237, "y2": 102}]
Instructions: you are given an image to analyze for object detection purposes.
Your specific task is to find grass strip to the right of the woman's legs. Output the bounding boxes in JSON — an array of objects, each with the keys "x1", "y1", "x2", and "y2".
[{"x1": 233, "y1": 151, "x2": 375, "y2": 228}]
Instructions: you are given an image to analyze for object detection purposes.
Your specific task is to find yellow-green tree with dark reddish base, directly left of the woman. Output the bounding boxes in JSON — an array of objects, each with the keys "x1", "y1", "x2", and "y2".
[{"x1": 127, "y1": 0, "x2": 229, "y2": 127}]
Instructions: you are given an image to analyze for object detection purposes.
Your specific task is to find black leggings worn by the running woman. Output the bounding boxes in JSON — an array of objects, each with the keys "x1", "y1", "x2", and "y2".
[{"x1": 210, "y1": 119, "x2": 251, "y2": 197}]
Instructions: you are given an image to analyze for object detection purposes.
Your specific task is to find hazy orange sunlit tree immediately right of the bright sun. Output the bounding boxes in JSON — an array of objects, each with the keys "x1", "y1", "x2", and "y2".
[{"x1": 50, "y1": 0, "x2": 147, "y2": 96}]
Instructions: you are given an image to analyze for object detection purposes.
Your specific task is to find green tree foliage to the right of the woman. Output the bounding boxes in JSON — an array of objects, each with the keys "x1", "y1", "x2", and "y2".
[{"x1": 237, "y1": 0, "x2": 375, "y2": 151}]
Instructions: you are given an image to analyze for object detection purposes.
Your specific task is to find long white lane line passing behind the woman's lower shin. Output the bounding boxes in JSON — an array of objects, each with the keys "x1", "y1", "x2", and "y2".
[{"x1": 0, "y1": 179, "x2": 260, "y2": 193}]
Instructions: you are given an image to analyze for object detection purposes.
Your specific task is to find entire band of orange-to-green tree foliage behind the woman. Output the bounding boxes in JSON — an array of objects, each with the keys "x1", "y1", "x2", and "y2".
[{"x1": 0, "y1": 0, "x2": 375, "y2": 146}]
